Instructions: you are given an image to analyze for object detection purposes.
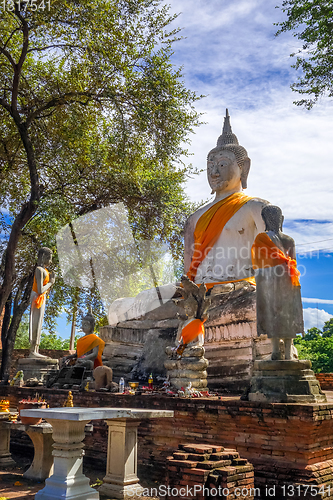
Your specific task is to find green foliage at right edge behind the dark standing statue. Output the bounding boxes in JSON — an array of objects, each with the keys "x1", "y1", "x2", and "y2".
[{"x1": 294, "y1": 318, "x2": 333, "y2": 373}]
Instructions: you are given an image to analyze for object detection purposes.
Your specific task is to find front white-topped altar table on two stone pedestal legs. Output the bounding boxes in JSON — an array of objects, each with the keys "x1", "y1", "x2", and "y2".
[{"x1": 21, "y1": 408, "x2": 174, "y2": 500}]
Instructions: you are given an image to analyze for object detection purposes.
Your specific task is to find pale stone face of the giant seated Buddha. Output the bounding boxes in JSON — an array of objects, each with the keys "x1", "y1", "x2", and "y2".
[{"x1": 207, "y1": 150, "x2": 242, "y2": 194}]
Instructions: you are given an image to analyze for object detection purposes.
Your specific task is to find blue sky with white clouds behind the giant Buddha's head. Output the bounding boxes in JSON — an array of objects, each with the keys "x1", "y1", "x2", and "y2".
[{"x1": 2, "y1": 0, "x2": 333, "y2": 337}]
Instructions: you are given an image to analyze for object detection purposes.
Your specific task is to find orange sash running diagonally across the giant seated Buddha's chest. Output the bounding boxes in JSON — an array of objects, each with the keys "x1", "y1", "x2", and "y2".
[{"x1": 187, "y1": 193, "x2": 253, "y2": 285}]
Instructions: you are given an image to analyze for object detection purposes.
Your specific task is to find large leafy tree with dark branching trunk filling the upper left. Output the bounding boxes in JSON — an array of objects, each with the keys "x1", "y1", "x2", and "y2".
[{"x1": 0, "y1": 0, "x2": 199, "y2": 377}]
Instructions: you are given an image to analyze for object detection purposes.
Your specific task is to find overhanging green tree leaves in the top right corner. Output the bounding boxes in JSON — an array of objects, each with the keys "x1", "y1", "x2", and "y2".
[{"x1": 276, "y1": 0, "x2": 333, "y2": 109}]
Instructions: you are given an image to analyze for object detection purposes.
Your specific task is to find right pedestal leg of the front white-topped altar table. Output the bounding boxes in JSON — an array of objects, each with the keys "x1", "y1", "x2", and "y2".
[{"x1": 98, "y1": 419, "x2": 143, "y2": 499}]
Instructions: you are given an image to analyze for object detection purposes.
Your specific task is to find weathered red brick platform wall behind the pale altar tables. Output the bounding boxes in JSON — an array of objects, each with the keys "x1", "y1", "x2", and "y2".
[{"x1": 0, "y1": 387, "x2": 333, "y2": 499}]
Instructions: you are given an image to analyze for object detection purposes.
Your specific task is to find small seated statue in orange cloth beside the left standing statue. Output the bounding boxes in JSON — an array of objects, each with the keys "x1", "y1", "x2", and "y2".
[{"x1": 63, "y1": 309, "x2": 105, "y2": 370}]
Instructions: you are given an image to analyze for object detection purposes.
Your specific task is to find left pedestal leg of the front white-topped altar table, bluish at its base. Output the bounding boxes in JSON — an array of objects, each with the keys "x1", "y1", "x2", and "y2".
[{"x1": 36, "y1": 418, "x2": 99, "y2": 500}]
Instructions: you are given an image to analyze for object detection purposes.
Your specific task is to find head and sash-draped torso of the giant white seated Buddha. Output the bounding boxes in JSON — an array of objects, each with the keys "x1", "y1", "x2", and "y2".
[{"x1": 184, "y1": 110, "x2": 268, "y2": 289}]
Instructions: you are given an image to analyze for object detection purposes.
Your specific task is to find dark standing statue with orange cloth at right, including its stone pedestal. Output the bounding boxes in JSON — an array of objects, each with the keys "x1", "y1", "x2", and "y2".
[{"x1": 249, "y1": 206, "x2": 326, "y2": 403}]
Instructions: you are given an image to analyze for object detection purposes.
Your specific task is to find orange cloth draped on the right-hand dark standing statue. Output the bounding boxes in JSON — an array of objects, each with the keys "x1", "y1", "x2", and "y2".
[{"x1": 251, "y1": 233, "x2": 301, "y2": 286}]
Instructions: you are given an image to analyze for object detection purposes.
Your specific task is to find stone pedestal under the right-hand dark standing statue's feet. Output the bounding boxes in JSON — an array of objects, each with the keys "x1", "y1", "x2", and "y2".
[{"x1": 248, "y1": 360, "x2": 326, "y2": 403}]
